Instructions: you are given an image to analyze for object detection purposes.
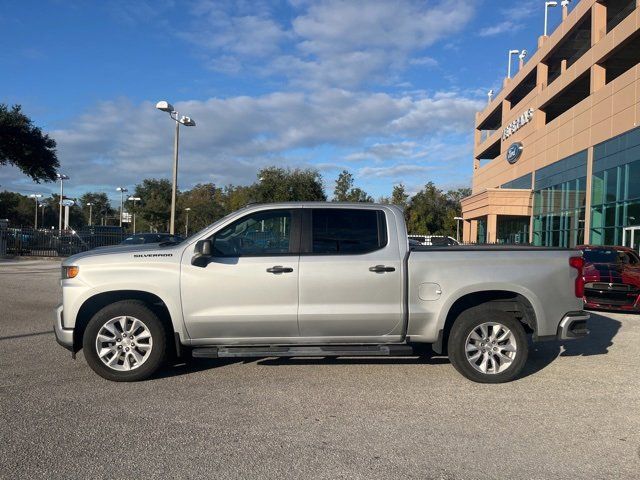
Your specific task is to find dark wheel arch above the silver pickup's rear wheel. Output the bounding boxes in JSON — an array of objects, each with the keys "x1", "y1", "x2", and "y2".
[{"x1": 433, "y1": 289, "x2": 539, "y2": 353}]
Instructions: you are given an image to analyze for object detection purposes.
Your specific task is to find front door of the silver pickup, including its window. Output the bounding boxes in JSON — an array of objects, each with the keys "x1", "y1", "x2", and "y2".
[{"x1": 180, "y1": 209, "x2": 300, "y2": 341}]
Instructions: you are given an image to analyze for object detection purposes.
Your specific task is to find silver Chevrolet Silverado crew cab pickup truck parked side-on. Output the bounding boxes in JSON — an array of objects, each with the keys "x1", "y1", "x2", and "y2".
[{"x1": 54, "y1": 203, "x2": 589, "y2": 383}]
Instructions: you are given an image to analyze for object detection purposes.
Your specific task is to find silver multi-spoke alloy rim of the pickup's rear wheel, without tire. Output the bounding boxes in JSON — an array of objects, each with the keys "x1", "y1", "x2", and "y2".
[{"x1": 465, "y1": 322, "x2": 518, "y2": 375}]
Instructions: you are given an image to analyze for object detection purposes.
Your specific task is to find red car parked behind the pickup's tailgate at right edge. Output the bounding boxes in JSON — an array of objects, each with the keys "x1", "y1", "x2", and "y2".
[{"x1": 577, "y1": 245, "x2": 640, "y2": 312}]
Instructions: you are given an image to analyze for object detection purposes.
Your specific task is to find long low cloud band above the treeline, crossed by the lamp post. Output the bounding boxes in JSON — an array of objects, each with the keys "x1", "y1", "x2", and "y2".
[{"x1": 0, "y1": 89, "x2": 479, "y2": 197}]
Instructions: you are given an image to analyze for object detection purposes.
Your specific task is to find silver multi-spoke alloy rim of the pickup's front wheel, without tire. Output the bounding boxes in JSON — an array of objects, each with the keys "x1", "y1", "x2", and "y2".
[{"x1": 96, "y1": 316, "x2": 153, "y2": 371}]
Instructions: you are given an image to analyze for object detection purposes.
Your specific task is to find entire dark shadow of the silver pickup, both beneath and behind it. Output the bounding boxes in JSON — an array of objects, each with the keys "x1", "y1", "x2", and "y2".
[{"x1": 153, "y1": 312, "x2": 622, "y2": 379}]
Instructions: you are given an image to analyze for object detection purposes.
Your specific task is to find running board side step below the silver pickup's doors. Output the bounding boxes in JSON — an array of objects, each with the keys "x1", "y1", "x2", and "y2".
[{"x1": 191, "y1": 345, "x2": 414, "y2": 358}]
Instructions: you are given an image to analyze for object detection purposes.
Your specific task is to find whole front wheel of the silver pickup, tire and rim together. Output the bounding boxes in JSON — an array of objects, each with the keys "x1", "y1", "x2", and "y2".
[{"x1": 82, "y1": 300, "x2": 167, "y2": 382}]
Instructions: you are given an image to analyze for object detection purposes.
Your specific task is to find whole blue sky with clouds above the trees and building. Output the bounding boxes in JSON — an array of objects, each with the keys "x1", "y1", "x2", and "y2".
[{"x1": 0, "y1": 0, "x2": 575, "y2": 203}]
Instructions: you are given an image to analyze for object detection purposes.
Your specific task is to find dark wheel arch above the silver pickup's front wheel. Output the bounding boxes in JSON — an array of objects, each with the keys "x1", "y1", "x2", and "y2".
[{"x1": 73, "y1": 290, "x2": 176, "y2": 353}]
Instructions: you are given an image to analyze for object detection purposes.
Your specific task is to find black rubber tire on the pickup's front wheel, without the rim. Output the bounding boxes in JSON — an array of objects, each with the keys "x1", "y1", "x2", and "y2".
[{"x1": 82, "y1": 300, "x2": 167, "y2": 382}]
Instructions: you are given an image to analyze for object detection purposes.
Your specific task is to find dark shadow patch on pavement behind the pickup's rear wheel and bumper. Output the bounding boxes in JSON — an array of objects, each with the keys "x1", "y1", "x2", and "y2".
[{"x1": 520, "y1": 312, "x2": 622, "y2": 378}]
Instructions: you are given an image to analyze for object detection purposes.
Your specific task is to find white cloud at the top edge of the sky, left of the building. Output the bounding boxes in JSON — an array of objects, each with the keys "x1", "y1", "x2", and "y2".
[{"x1": 179, "y1": 0, "x2": 476, "y2": 89}]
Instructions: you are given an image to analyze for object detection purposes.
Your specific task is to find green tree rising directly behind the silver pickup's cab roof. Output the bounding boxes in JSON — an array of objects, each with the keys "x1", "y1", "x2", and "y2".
[{"x1": 253, "y1": 167, "x2": 327, "y2": 203}]
